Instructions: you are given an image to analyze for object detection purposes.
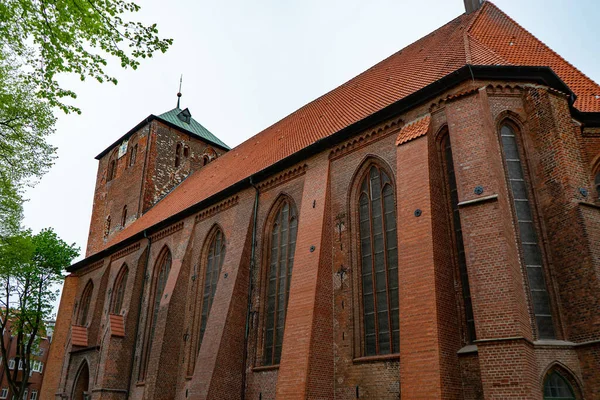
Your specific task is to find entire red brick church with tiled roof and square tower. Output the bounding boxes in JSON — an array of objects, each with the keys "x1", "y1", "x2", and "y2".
[{"x1": 42, "y1": 0, "x2": 600, "y2": 400}]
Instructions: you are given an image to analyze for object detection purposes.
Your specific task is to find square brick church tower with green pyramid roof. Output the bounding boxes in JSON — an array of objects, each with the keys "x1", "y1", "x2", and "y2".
[{"x1": 86, "y1": 105, "x2": 229, "y2": 256}]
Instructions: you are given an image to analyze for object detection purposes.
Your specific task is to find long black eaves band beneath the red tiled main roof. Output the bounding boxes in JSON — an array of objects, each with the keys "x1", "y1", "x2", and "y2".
[{"x1": 67, "y1": 65, "x2": 600, "y2": 272}]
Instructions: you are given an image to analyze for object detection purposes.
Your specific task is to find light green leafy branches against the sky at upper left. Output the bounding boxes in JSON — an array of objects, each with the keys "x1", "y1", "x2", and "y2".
[{"x1": 0, "y1": 0, "x2": 172, "y2": 231}]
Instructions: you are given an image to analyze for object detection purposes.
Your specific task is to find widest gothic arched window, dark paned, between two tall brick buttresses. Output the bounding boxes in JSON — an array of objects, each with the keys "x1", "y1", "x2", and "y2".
[{"x1": 356, "y1": 165, "x2": 400, "y2": 356}]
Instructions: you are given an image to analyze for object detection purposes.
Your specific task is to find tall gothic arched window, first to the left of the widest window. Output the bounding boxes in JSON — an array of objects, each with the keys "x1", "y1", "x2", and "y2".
[{"x1": 264, "y1": 198, "x2": 298, "y2": 365}]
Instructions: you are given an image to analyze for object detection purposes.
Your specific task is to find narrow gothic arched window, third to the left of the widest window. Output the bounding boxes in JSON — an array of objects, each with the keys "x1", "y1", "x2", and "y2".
[{"x1": 139, "y1": 246, "x2": 172, "y2": 380}]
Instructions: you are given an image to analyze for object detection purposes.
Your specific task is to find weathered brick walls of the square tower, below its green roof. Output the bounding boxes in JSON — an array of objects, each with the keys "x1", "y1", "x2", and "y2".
[{"x1": 86, "y1": 120, "x2": 225, "y2": 256}]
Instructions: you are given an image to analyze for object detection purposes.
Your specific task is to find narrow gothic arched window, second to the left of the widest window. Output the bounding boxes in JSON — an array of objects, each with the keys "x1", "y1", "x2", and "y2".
[{"x1": 197, "y1": 228, "x2": 225, "y2": 351}]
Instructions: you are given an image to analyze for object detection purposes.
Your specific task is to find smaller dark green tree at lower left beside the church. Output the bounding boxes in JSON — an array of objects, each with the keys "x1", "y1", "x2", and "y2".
[{"x1": 0, "y1": 229, "x2": 79, "y2": 398}]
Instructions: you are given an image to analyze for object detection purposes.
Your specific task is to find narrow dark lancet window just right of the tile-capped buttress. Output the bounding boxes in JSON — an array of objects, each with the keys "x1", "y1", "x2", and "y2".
[{"x1": 442, "y1": 132, "x2": 476, "y2": 343}]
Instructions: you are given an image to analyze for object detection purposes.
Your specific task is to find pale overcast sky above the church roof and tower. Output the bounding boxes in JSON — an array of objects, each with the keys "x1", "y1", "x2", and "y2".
[{"x1": 24, "y1": 0, "x2": 600, "y2": 272}]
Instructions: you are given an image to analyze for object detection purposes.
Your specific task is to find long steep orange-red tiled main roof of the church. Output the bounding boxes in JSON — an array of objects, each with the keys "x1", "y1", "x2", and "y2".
[{"x1": 99, "y1": 2, "x2": 600, "y2": 255}]
